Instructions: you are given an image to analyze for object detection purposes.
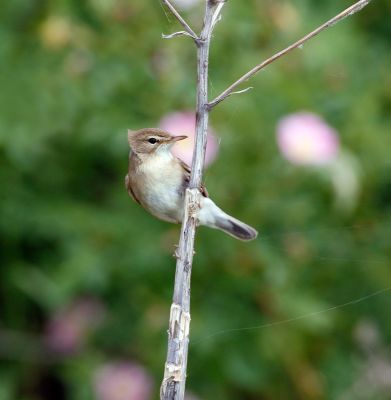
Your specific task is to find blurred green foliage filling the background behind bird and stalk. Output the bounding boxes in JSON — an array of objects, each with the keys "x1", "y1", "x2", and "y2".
[{"x1": 0, "y1": 0, "x2": 391, "y2": 400}]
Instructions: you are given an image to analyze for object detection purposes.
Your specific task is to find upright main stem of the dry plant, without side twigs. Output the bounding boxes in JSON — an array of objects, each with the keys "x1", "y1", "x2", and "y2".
[{"x1": 160, "y1": 0, "x2": 224, "y2": 400}]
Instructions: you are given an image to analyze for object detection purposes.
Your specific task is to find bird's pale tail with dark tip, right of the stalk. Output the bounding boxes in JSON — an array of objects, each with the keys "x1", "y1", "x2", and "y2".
[{"x1": 199, "y1": 198, "x2": 258, "y2": 241}]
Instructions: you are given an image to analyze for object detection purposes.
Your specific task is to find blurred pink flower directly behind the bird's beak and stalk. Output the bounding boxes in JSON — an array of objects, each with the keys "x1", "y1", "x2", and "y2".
[{"x1": 159, "y1": 112, "x2": 219, "y2": 166}]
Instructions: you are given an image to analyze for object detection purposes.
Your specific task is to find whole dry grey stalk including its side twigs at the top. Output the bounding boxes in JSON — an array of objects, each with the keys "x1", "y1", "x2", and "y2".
[{"x1": 160, "y1": 0, "x2": 370, "y2": 400}]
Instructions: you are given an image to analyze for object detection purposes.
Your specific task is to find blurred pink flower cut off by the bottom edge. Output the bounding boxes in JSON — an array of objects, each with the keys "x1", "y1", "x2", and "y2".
[{"x1": 94, "y1": 362, "x2": 152, "y2": 400}]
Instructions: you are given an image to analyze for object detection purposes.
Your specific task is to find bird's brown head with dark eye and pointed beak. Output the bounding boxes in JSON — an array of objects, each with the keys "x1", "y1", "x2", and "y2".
[{"x1": 128, "y1": 128, "x2": 187, "y2": 154}]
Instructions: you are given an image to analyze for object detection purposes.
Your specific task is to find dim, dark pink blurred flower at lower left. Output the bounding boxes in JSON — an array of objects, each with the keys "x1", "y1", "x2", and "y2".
[{"x1": 45, "y1": 299, "x2": 104, "y2": 353}]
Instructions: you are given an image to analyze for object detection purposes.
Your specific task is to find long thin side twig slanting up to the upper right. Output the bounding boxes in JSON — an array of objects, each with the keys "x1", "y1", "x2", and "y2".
[{"x1": 208, "y1": 0, "x2": 371, "y2": 110}]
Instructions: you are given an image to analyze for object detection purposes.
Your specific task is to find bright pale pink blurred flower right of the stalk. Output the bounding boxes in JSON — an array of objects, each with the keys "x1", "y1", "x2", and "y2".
[{"x1": 277, "y1": 112, "x2": 339, "y2": 165}]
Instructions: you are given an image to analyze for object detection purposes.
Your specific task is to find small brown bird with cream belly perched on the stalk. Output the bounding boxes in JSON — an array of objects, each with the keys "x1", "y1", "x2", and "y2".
[{"x1": 125, "y1": 128, "x2": 258, "y2": 240}]
